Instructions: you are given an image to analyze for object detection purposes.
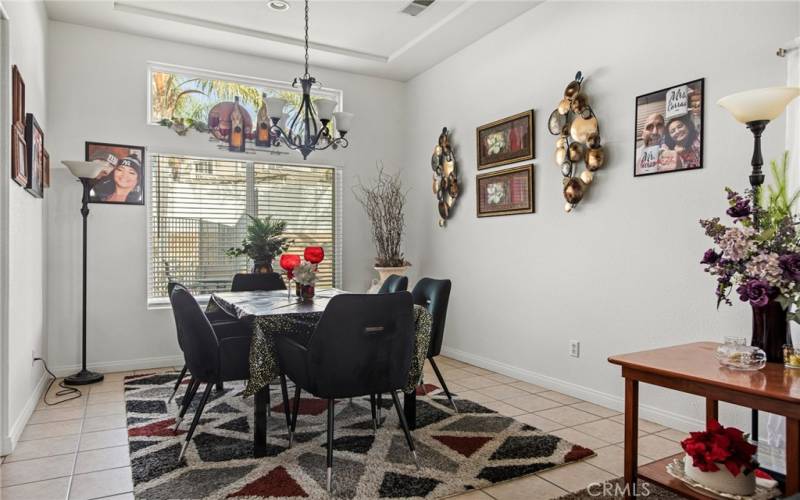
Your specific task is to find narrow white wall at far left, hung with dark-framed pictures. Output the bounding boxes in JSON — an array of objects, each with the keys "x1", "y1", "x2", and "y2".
[{"x1": 0, "y1": 1, "x2": 50, "y2": 453}]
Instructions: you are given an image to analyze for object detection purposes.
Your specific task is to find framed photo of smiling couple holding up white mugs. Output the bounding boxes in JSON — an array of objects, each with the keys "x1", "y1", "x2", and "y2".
[{"x1": 633, "y1": 78, "x2": 705, "y2": 177}]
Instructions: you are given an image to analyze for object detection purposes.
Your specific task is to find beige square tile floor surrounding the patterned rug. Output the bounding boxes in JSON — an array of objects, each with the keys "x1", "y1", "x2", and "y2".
[{"x1": 0, "y1": 357, "x2": 683, "y2": 500}]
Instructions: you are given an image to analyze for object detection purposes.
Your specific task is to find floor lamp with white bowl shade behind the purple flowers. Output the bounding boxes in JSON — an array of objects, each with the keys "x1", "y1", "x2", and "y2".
[{"x1": 717, "y1": 87, "x2": 800, "y2": 441}]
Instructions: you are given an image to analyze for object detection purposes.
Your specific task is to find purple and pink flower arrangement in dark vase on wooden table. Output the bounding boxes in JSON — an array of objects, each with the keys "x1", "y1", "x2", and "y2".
[{"x1": 700, "y1": 151, "x2": 800, "y2": 362}]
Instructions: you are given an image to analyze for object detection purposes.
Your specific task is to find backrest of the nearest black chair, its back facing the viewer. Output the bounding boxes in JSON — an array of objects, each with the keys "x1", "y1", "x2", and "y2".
[{"x1": 308, "y1": 292, "x2": 414, "y2": 398}]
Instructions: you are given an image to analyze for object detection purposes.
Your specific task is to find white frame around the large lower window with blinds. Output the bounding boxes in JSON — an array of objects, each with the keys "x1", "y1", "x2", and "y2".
[{"x1": 145, "y1": 150, "x2": 344, "y2": 309}]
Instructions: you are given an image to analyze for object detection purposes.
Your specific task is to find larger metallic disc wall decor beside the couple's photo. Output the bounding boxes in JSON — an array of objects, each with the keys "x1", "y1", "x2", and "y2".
[{"x1": 547, "y1": 71, "x2": 605, "y2": 212}]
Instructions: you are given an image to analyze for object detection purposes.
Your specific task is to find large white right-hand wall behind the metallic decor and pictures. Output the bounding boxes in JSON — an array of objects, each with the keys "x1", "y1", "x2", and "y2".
[{"x1": 406, "y1": 2, "x2": 798, "y2": 427}]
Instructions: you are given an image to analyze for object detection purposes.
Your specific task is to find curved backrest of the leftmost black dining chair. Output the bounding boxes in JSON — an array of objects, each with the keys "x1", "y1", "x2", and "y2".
[{"x1": 169, "y1": 286, "x2": 219, "y2": 382}]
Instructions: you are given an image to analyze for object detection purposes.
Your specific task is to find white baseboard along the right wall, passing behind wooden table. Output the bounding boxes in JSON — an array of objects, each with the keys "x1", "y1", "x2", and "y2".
[{"x1": 442, "y1": 347, "x2": 706, "y2": 432}]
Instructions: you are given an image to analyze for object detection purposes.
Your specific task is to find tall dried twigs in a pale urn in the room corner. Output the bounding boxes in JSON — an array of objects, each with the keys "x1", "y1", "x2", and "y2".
[{"x1": 353, "y1": 165, "x2": 411, "y2": 291}]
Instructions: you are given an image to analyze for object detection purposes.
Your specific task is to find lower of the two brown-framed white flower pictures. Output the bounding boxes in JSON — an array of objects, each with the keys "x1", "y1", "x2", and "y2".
[{"x1": 475, "y1": 164, "x2": 533, "y2": 217}]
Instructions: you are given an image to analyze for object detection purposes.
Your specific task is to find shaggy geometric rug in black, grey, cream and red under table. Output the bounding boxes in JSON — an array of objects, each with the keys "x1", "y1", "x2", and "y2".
[{"x1": 125, "y1": 373, "x2": 594, "y2": 499}]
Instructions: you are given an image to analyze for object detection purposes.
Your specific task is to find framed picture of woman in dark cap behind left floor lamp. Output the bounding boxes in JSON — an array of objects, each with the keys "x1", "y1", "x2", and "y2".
[{"x1": 86, "y1": 142, "x2": 146, "y2": 205}]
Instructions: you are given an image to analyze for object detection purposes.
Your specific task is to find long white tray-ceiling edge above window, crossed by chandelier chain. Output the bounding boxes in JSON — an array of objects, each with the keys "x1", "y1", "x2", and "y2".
[{"x1": 114, "y1": 0, "x2": 388, "y2": 64}]
